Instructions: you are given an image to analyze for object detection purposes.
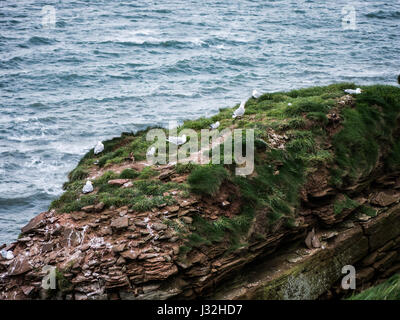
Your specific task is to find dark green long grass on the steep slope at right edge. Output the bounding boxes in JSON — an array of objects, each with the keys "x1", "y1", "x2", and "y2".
[{"x1": 332, "y1": 85, "x2": 400, "y2": 187}]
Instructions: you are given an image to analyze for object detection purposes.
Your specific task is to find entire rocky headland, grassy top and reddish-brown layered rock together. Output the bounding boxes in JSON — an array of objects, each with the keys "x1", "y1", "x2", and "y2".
[{"x1": 0, "y1": 83, "x2": 400, "y2": 300}]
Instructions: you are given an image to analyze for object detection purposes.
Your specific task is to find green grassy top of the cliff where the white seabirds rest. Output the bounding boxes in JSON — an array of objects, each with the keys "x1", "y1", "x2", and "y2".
[{"x1": 51, "y1": 83, "x2": 400, "y2": 252}]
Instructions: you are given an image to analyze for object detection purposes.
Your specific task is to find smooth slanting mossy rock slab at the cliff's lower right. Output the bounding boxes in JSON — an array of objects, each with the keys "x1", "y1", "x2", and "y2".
[{"x1": 212, "y1": 205, "x2": 400, "y2": 300}]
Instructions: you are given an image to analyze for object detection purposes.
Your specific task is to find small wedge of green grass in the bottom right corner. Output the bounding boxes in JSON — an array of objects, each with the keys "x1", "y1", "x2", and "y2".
[{"x1": 348, "y1": 274, "x2": 400, "y2": 300}]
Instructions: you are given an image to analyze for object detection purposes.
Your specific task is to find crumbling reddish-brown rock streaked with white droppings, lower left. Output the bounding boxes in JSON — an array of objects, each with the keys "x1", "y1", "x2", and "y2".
[{"x1": 0, "y1": 182, "x2": 244, "y2": 300}]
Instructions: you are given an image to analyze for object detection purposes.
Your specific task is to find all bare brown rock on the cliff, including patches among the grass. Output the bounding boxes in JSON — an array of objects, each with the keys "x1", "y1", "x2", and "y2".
[{"x1": 0, "y1": 137, "x2": 400, "y2": 300}]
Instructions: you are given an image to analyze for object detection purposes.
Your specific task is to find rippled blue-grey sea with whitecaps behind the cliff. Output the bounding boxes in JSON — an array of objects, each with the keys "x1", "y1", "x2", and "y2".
[{"x1": 0, "y1": 0, "x2": 400, "y2": 244}]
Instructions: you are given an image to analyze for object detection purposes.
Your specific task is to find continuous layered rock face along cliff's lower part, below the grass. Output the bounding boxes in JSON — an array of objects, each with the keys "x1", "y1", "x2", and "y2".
[{"x1": 0, "y1": 170, "x2": 400, "y2": 300}]
